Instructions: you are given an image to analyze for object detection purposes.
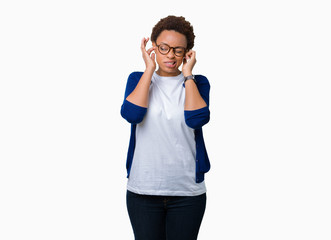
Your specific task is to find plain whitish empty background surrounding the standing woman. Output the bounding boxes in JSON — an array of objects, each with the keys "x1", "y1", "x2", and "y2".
[{"x1": 0, "y1": 0, "x2": 331, "y2": 240}]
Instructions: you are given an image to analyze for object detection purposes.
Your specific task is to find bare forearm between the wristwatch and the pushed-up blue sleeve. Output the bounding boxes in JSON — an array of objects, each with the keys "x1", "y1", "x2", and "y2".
[{"x1": 184, "y1": 79, "x2": 207, "y2": 111}]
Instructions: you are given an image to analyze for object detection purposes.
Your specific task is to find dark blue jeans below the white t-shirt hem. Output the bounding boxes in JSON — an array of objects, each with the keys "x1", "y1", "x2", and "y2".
[{"x1": 126, "y1": 191, "x2": 206, "y2": 240}]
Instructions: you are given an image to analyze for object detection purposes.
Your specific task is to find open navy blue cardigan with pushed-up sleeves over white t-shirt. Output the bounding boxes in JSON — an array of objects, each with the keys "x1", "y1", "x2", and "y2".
[{"x1": 121, "y1": 72, "x2": 210, "y2": 183}]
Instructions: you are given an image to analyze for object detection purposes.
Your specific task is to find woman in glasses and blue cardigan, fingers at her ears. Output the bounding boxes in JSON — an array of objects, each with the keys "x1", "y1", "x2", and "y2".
[{"x1": 121, "y1": 16, "x2": 210, "y2": 240}]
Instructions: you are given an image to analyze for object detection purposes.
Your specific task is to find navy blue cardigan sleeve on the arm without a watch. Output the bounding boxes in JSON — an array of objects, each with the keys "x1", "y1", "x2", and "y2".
[{"x1": 121, "y1": 72, "x2": 147, "y2": 124}]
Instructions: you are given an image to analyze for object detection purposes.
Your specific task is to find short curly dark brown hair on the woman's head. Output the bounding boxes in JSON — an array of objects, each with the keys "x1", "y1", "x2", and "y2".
[{"x1": 151, "y1": 15, "x2": 195, "y2": 50}]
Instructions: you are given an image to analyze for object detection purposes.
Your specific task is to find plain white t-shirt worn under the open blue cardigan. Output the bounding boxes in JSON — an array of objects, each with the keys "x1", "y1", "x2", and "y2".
[{"x1": 127, "y1": 72, "x2": 206, "y2": 196}]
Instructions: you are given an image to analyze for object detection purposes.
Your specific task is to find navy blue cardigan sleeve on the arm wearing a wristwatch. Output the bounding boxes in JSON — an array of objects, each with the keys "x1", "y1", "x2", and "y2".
[{"x1": 184, "y1": 75, "x2": 210, "y2": 129}]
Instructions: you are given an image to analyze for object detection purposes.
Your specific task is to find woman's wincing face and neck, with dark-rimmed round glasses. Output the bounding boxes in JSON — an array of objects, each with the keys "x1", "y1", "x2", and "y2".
[{"x1": 153, "y1": 30, "x2": 187, "y2": 76}]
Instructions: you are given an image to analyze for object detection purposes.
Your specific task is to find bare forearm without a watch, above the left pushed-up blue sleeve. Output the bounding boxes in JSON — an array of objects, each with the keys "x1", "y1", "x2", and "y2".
[{"x1": 126, "y1": 69, "x2": 154, "y2": 108}]
